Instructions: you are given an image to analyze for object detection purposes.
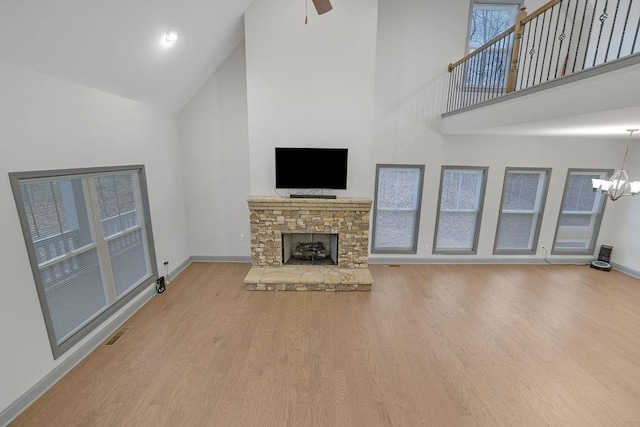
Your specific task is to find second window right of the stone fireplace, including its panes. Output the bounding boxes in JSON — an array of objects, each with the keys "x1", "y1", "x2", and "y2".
[{"x1": 433, "y1": 166, "x2": 488, "y2": 254}]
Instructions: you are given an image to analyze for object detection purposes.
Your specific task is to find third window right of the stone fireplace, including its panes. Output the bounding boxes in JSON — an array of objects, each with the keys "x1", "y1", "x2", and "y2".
[{"x1": 493, "y1": 168, "x2": 551, "y2": 254}]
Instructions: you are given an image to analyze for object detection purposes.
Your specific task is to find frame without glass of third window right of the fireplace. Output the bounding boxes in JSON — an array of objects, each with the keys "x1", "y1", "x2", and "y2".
[{"x1": 493, "y1": 167, "x2": 551, "y2": 255}]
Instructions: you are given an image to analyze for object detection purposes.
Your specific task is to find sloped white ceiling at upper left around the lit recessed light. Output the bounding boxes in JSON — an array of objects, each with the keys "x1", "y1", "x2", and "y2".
[{"x1": 0, "y1": 0, "x2": 251, "y2": 111}]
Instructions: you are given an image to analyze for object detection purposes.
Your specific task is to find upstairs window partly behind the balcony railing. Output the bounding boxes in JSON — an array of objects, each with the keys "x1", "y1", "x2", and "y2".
[{"x1": 466, "y1": 0, "x2": 520, "y2": 88}]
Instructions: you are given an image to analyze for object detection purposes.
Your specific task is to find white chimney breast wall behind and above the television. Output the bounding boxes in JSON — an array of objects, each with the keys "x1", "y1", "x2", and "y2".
[{"x1": 245, "y1": 0, "x2": 378, "y2": 196}]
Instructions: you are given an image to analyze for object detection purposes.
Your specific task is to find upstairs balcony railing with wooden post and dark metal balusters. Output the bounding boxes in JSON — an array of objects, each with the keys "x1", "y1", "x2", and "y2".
[{"x1": 446, "y1": 0, "x2": 640, "y2": 112}]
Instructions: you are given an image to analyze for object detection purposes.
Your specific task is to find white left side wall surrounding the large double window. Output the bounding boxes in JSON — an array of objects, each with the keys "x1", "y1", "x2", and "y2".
[{"x1": 0, "y1": 62, "x2": 189, "y2": 412}]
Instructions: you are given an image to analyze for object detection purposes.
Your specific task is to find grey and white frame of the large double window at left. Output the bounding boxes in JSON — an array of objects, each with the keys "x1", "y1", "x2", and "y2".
[{"x1": 9, "y1": 165, "x2": 158, "y2": 359}]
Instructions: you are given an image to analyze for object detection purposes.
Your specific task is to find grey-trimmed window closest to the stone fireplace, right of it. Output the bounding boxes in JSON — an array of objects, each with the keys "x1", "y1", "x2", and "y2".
[{"x1": 371, "y1": 165, "x2": 424, "y2": 254}]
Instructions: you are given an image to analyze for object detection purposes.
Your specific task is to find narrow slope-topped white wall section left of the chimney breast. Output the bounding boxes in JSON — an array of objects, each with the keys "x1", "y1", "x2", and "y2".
[{"x1": 179, "y1": 43, "x2": 250, "y2": 257}]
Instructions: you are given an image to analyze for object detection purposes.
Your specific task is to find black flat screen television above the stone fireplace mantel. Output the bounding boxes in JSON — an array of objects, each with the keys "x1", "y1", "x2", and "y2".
[{"x1": 276, "y1": 147, "x2": 348, "y2": 190}]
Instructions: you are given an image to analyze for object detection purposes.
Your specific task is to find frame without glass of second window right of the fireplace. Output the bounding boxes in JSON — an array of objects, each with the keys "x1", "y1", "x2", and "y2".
[{"x1": 432, "y1": 166, "x2": 489, "y2": 255}]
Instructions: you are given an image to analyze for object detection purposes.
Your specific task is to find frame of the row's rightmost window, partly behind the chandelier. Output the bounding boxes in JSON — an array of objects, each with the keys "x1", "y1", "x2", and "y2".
[{"x1": 551, "y1": 168, "x2": 613, "y2": 255}]
